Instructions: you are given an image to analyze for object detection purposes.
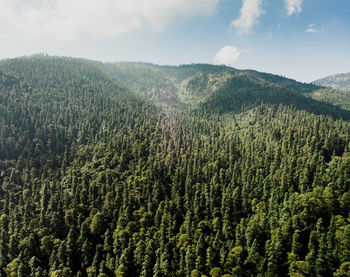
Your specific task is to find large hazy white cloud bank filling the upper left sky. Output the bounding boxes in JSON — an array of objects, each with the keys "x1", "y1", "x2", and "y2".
[{"x1": 0, "y1": 0, "x2": 219, "y2": 41}]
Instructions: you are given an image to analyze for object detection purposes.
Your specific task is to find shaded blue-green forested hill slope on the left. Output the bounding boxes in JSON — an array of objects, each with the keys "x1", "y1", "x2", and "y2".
[{"x1": 0, "y1": 56, "x2": 158, "y2": 176}]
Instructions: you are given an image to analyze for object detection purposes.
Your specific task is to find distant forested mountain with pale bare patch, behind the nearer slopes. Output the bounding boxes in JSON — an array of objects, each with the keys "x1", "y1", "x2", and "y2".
[{"x1": 106, "y1": 63, "x2": 350, "y2": 118}]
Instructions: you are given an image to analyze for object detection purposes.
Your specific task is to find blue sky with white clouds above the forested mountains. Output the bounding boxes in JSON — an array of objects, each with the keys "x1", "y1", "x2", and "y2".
[{"x1": 0, "y1": 0, "x2": 350, "y2": 82}]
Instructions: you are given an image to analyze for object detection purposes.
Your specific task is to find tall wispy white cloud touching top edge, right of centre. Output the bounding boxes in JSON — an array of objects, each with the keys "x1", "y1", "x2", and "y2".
[{"x1": 231, "y1": 0, "x2": 264, "y2": 34}]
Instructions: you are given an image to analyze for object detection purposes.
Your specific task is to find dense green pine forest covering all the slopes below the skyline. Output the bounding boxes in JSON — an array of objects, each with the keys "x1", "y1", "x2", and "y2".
[{"x1": 0, "y1": 55, "x2": 350, "y2": 277}]
